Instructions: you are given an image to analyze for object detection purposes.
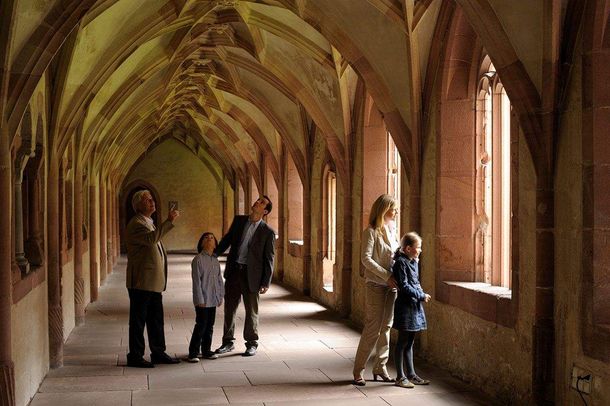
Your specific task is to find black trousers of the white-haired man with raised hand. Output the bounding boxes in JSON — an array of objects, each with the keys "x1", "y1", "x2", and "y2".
[{"x1": 127, "y1": 289, "x2": 165, "y2": 361}]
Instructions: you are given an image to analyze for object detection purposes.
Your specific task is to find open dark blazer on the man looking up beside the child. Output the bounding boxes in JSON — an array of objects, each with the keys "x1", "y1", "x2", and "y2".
[{"x1": 215, "y1": 215, "x2": 275, "y2": 293}]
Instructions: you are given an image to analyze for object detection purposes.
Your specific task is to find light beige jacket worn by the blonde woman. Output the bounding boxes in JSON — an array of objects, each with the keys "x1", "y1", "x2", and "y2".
[{"x1": 360, "y1": 227, "x2": 398, "y2": 285}]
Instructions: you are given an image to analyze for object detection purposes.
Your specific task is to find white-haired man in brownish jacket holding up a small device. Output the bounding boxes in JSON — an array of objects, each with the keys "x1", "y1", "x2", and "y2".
[{"x1": 125, "y1": 190, "x2": 180, "y2": 368}]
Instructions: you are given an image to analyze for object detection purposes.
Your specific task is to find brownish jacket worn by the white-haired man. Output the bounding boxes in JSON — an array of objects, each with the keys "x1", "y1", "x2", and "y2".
[{"x1": 125, "y1": 214, "x2": 174, "y2": 292}]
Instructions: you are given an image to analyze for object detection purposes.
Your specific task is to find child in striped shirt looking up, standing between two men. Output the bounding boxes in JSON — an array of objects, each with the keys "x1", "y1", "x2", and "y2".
[{"x1": 188, "y1": 232, "x2": 225, "y2": 362}]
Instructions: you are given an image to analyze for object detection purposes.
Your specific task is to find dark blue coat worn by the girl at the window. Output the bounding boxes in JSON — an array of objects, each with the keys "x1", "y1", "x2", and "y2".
[{"x1": 392, "y1": 252, "x2": 428, "y2": 331}]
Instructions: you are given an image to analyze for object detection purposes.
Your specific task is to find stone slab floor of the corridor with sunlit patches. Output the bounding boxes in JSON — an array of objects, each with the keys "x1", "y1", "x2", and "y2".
[{"x1": 31, "y1": 256, "x2": 494, "y2": 406}]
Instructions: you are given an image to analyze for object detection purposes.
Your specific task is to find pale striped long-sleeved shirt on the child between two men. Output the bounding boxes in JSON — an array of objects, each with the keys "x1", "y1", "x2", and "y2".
[{"x1": 191, "y1": 251, "x2": 225, "y2": 307}]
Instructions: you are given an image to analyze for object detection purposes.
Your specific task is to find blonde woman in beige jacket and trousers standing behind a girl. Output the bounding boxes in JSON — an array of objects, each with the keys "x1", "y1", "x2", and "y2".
[{"x1": 353, "y1": 195, "x2": 399, "y2": 386}]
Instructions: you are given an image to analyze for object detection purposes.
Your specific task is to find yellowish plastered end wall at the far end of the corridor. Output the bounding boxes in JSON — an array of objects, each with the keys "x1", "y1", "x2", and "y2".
[{"x1": 122, "y1": 139, "x2": 222, "y2": 251}]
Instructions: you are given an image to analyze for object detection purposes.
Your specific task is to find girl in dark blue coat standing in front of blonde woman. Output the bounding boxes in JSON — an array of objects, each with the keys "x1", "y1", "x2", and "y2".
[{"x1": 392, "y1": 232, "x2": 430, "y2": 388}]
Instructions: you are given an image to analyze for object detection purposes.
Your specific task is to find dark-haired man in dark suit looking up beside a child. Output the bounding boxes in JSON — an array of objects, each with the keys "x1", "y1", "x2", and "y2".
[{"x1": 211, "y1": 196, "x2": 275, "y2": 356}]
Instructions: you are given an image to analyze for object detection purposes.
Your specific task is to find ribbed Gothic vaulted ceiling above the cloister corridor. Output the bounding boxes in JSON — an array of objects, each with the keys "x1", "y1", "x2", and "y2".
[{"x1": 1, "y1": 0, "x2": 543, "y2": 190}]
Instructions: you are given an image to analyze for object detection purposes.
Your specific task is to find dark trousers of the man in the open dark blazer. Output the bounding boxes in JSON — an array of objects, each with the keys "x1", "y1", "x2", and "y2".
[{"x1": 222, "y1": 267, "x2": 259, "y2": 348}]
